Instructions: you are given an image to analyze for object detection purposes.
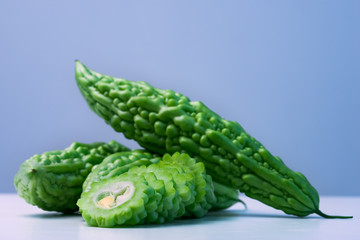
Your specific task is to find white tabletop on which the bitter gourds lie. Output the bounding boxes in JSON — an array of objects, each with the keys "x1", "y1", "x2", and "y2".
[{"x1": 0, "y1": 194, "x2": 360, "y2": 240}]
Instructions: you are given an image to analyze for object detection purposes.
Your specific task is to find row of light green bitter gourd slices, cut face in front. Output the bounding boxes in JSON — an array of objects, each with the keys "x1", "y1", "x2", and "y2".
[{"x1": 78, "y1": 153, "x2": 215, "y2": 227}]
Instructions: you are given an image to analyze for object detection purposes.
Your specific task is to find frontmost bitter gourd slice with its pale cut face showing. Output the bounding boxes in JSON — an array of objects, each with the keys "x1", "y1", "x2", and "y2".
[{"x1": 77, "y1": 173, "x2": 155, "y2": 227}]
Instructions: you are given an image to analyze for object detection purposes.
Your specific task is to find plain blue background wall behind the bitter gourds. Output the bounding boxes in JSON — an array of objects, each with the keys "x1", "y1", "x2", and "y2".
[{"x1": 0, "y1": 0, "x2": 360, "y2": 195}]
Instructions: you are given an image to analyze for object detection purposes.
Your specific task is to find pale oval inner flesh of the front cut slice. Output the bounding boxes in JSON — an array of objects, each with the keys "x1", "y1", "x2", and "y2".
[{"x1": 93, "y1": 182, "x2": 135, "y2": 209}]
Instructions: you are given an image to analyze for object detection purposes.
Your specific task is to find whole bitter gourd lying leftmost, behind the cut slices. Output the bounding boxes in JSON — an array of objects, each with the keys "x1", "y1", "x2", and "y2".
[{"x1": 14, "y1": 141, "x2": 129, "y2": 213}]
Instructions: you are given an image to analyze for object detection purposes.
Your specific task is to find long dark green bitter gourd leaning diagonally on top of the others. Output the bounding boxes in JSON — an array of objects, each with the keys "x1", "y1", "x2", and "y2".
[{"x1": 75, "y1": 61, "x2": 352, "y2": 217}]
